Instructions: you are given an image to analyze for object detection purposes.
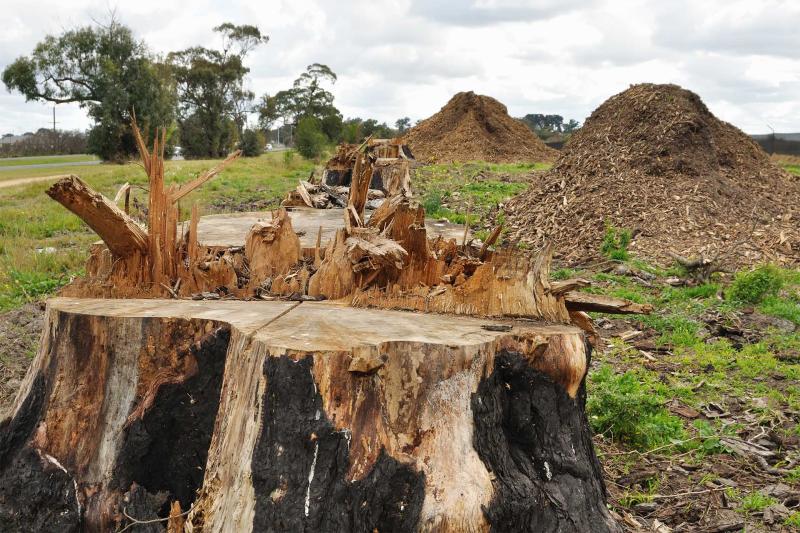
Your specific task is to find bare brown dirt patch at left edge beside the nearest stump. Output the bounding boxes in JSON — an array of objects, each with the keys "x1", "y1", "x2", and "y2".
[{"x1": 0, "y1": 302, "x2": 44, "y2": 420}]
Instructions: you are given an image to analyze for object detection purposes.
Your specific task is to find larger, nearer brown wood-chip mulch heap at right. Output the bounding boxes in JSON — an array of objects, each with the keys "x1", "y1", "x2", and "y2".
[{"x1": 504, "y1": 84, "x2": 800, "y2": 267}]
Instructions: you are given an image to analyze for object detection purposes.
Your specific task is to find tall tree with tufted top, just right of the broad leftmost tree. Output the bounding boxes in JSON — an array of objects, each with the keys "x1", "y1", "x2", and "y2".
[{"x1": 169, "y1": 22, "x2": 269, "y2": 157}]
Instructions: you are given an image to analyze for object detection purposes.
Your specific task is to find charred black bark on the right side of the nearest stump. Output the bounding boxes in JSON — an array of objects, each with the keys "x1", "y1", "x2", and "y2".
[{"x1": 472, "y1": 349, "x2": 619, "y2": 533}]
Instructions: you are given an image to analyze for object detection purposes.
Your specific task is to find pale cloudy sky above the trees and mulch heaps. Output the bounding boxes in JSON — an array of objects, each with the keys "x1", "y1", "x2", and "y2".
[{"x1": 0, "y1": 0, "x2": 800, "y2": 133}]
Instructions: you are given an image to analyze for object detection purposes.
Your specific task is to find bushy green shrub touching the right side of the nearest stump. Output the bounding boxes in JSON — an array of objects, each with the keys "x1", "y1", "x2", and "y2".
[{"x1": 587, "y1": 365, "x2": 686, "y2": 450}]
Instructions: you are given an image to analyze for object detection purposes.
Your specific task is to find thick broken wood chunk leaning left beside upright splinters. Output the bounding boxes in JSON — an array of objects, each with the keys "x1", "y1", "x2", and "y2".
[{"x1": 47, "y1": 176, "x2": 148, "y2": 258}]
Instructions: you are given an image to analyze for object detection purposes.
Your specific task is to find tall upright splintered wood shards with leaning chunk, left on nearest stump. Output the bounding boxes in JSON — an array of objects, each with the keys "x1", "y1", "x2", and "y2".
[{"x1": 47, "y1": 117, "x2": 241, "y2": 297}]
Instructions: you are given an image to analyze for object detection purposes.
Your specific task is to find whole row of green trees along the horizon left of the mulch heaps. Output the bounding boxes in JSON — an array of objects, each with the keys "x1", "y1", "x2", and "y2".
[{"x1": 2, "y1": 17, "x2": 418, "y2": 161}]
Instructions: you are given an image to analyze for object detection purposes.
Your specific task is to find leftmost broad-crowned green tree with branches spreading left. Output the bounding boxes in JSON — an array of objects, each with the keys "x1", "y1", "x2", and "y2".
[{"x1": 3, "y1": 17, "x2": 175, "y2": 160}]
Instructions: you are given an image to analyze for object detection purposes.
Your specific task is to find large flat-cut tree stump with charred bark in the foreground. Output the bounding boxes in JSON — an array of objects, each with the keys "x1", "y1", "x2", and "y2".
[{"x1": 0, "y1": 298, "x2": 617, "y2": 532}]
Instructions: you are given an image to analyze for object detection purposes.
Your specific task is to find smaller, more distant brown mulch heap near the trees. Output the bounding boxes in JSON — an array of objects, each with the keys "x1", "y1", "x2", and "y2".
[{"x1": 404, "y1": 91, "x2": 557, "y2": 163}]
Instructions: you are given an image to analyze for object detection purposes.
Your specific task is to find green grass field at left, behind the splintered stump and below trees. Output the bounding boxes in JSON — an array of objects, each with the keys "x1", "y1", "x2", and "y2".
[{"x1": 0, "y1": 152, "x2": 314, "y2": 311}]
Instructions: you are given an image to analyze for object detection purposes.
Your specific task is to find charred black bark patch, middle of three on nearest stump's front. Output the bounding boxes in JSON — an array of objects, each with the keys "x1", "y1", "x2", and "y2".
[{"x1": 252, "y1": 356, "x2": 425, "y2": 533}]
